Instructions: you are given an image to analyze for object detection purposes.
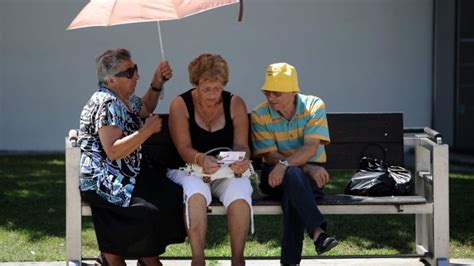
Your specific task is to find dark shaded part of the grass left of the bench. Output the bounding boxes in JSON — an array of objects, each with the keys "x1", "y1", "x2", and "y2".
[{"x1": 0, "y1": 155, "x2": 65, "y2": 242}]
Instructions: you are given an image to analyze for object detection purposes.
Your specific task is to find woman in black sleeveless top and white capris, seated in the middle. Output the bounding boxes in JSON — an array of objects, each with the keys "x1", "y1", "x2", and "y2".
[{"x1": 168, "y1": 54, "x2": 252, "y2": 265}]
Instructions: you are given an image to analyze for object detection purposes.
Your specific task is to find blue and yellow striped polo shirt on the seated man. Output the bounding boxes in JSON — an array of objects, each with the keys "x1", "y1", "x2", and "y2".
[{"x1": 251, "y1": 93, "x2": 330, "y2": 163}]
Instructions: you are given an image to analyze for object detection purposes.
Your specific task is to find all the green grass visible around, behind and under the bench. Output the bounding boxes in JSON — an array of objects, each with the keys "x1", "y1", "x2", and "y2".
[{"x1": 0, "y1": 155, "x2": 474, "y2": 262}]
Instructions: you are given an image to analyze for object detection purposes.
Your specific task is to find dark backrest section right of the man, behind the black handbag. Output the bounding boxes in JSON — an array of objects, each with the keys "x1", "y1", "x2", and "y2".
[{"x1": 326, "y1": 113, "x2": 404, "y2": 169}]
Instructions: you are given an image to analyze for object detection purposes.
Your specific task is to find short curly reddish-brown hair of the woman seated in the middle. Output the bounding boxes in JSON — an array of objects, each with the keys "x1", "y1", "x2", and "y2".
[{"x1": 188, "y1": 54, "x2": 229, "y2": 86}]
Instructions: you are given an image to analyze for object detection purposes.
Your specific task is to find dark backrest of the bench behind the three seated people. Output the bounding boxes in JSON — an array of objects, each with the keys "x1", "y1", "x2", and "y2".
[{"x1": 142, "y1": 113, "x2": 404, "y2": 169}]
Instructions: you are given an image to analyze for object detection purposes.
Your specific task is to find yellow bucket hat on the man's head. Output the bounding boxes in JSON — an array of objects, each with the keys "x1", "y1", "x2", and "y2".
[{"x1": 262, "y1": 63, "x2": 300, "y2": 92}]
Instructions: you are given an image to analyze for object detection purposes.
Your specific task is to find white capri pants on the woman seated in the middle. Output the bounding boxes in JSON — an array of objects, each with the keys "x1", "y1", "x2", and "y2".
[{"x1": 166, "y1": 169, "x2": 254, "y2": 234}]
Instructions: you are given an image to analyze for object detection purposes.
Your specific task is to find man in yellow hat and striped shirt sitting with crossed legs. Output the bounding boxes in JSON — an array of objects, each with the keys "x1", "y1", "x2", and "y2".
[{"x1": 251, "y1": 63, "x2": 338, "y2": 265}]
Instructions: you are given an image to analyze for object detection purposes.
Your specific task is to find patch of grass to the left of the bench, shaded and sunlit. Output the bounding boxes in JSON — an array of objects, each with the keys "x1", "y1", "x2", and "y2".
[{"x1": 0, "y1": 156, "x2": 65, "y2": 261}]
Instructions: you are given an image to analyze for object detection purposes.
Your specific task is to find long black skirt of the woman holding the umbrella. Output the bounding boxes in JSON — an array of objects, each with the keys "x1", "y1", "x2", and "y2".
[{"x1": 81, "y1": 166, "x2": 186, "y2": 258}]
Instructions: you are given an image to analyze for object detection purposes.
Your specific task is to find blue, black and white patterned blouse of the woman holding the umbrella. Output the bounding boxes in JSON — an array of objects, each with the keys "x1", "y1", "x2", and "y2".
[{"x1": 78, "y1": 87, "x2": 143, "y2": 207}]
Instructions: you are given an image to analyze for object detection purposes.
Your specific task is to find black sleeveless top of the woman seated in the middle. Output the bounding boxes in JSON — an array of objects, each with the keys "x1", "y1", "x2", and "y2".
[{"x1": 180, "y1": 89, "x2": 234, "y2": 155}]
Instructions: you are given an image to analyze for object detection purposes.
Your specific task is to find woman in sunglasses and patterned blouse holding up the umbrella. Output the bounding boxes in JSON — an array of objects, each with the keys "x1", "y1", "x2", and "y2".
[{"x1": 79, "y1": 49, "x2": 186, "y2": 265}]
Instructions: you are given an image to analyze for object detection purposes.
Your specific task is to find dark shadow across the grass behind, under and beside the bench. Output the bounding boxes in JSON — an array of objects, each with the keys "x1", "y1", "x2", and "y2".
[{"x1": 0, "y1": 155, "x2": 474, "y2": 256}]
